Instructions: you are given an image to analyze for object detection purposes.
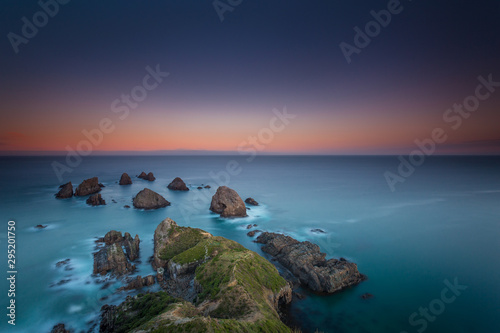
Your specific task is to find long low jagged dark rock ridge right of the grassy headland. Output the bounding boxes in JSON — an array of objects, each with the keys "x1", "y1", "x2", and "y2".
[{"x1": 256, "y1": 232, "x2": 366, "y2": 293}]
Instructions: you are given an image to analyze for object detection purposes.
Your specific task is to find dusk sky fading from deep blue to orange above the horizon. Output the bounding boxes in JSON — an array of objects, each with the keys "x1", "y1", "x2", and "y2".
[{"x1": 0, "y1": 0, "x2": 500, "y2": 155}]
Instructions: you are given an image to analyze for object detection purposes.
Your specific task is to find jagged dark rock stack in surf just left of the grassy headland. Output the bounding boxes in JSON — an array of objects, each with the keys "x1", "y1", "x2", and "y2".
[{"x1": 94, "y1": 230, "x2": 140, "y2": 276}]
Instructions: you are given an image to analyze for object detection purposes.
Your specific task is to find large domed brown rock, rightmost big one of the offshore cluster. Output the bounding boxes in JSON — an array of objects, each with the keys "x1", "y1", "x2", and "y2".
[{"x1": 210, "y1": 186, "x2": 247, "y2": 217}]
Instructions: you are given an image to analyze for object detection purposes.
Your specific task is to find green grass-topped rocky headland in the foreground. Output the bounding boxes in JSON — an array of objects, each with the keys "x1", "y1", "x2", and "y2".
[{"x1": 100, "y1": 219, "x2": 292, "y2": 333}]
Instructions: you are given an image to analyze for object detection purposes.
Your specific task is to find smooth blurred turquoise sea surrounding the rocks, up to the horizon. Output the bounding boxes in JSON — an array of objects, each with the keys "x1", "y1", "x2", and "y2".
[{"x1": 0, "y1": 156, "x2": 500, "y2": 333}]
